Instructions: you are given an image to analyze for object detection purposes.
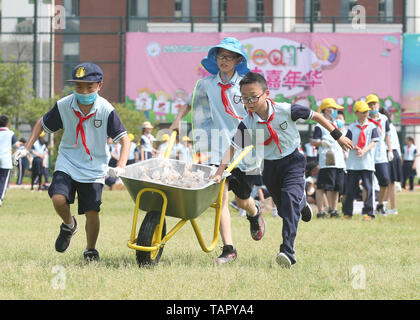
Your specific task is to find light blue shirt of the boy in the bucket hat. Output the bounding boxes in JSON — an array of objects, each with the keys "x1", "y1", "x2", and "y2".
[{"x1": 187, "y1": 72, "x2": 260, "y2": 172}]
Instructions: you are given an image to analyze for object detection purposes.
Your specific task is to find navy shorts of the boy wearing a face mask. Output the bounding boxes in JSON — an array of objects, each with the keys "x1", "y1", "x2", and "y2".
[{"x1": 48, "y1": 171, "x2": 103, "y2": 214}]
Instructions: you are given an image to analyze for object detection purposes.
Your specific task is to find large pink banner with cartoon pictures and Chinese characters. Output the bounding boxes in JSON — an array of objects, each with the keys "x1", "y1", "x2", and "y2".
[{"x1": 126, "y1": 33, "x2": 401, "y2": 122}]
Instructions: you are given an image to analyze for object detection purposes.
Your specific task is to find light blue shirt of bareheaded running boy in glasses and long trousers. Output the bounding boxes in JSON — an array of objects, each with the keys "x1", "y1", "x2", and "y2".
[{"x1": 232, "y1": 100, "x2": 314, "y2": 160}]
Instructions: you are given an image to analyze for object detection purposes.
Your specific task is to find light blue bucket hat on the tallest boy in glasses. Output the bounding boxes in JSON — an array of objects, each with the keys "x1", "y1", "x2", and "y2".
[{"x1": 201, "y1": 37, "x2": 250, "y2": 74}]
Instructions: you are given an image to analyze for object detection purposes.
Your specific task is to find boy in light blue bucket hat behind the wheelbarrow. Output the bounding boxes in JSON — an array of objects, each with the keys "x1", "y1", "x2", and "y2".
[{"x1": 170, "y1": 37, "x2": 265, "y2": 264}]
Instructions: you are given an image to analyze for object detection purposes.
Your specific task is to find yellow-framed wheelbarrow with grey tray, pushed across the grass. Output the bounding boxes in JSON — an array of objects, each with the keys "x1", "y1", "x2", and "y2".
[{"x1": 121, "y1": 132, "x2": 253, "y2": 267}]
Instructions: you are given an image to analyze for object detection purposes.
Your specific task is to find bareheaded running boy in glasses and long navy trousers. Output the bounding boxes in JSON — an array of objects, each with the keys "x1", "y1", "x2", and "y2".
[{"x1": 215, "y1": 72, "x2": 353, "y2": 268}]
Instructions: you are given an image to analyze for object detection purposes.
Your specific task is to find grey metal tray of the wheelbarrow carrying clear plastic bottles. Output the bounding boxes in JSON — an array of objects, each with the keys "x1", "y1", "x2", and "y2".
[{"x1": 120, "y1": 158, "x2": 230, "y2": 220}]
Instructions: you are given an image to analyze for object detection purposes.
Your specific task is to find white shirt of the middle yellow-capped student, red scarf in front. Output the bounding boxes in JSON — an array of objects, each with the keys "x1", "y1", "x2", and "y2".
[{"x1": 346, "y1": 120, "x2": 379, "y2": 171}]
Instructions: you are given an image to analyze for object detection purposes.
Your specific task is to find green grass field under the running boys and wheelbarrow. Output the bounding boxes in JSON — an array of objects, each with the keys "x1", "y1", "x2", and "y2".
[{"x1": 0, "y1": 185, "x2": 420, "y2": 300}]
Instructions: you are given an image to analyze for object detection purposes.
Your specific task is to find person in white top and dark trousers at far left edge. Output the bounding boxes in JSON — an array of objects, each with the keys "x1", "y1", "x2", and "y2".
[{"x1": 0, "y1": 115, "x2": 19, "y2": 207}]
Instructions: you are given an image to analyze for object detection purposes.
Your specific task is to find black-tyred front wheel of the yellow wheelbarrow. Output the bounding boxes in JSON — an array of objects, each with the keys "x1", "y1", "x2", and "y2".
[{"x1": 136, "y1": 211, "x2": 166, "y2": 267}]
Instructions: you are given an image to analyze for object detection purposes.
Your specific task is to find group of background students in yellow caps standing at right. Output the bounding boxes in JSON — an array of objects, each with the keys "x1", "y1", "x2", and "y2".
[{"x1": 302, "y1": 94, "x2": 417, "y2": 220}]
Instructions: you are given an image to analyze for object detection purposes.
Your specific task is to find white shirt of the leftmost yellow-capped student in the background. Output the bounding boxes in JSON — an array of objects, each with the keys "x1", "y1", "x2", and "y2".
[{"x1": 312, "y1": 121, "x2": 346, "y2": 169}]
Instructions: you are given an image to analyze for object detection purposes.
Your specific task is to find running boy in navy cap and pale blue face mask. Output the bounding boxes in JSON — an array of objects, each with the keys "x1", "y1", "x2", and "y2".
[{"x1": 14, "y1": 62, "x2": 130, "y2": 262}]
